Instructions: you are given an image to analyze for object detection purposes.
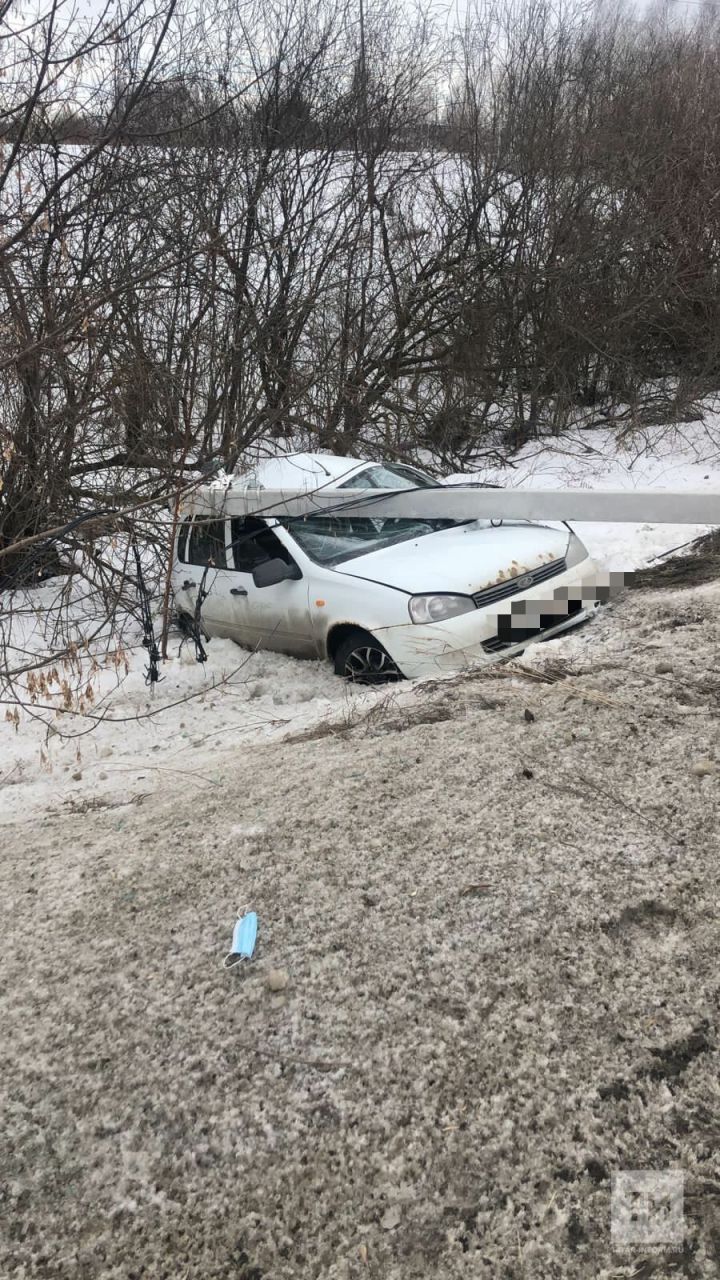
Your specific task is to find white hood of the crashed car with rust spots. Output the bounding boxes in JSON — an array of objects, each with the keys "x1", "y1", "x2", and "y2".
[{"x1": 336, "y1": 521, "x2": 568, "y2": 595}]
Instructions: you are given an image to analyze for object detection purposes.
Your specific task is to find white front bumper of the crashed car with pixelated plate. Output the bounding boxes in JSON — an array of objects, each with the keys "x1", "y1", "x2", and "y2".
[{"x1": 373, "y1": 557, "x2": 607, "y2": 680}]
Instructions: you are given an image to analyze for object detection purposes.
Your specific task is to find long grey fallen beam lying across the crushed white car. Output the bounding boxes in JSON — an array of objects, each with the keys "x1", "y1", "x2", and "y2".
[{"x1": 186, "y1": 485, "x2": 720, "y2": 525}]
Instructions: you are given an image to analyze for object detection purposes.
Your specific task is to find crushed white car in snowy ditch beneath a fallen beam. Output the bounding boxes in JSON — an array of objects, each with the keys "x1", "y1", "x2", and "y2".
[{"x1": 173, "y1": 453, "x2": 597, "y2": 684}]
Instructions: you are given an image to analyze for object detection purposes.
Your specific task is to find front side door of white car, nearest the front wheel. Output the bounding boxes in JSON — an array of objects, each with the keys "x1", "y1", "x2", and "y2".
[{"x1": 231, "y1": 516, "x2": 318, "y2": 658}]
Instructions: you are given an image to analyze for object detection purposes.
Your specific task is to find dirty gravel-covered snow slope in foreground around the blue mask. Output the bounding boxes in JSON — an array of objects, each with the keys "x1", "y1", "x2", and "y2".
[{"x1": 0, "y1": 586, "x2": 720, "y2": 1280}]
